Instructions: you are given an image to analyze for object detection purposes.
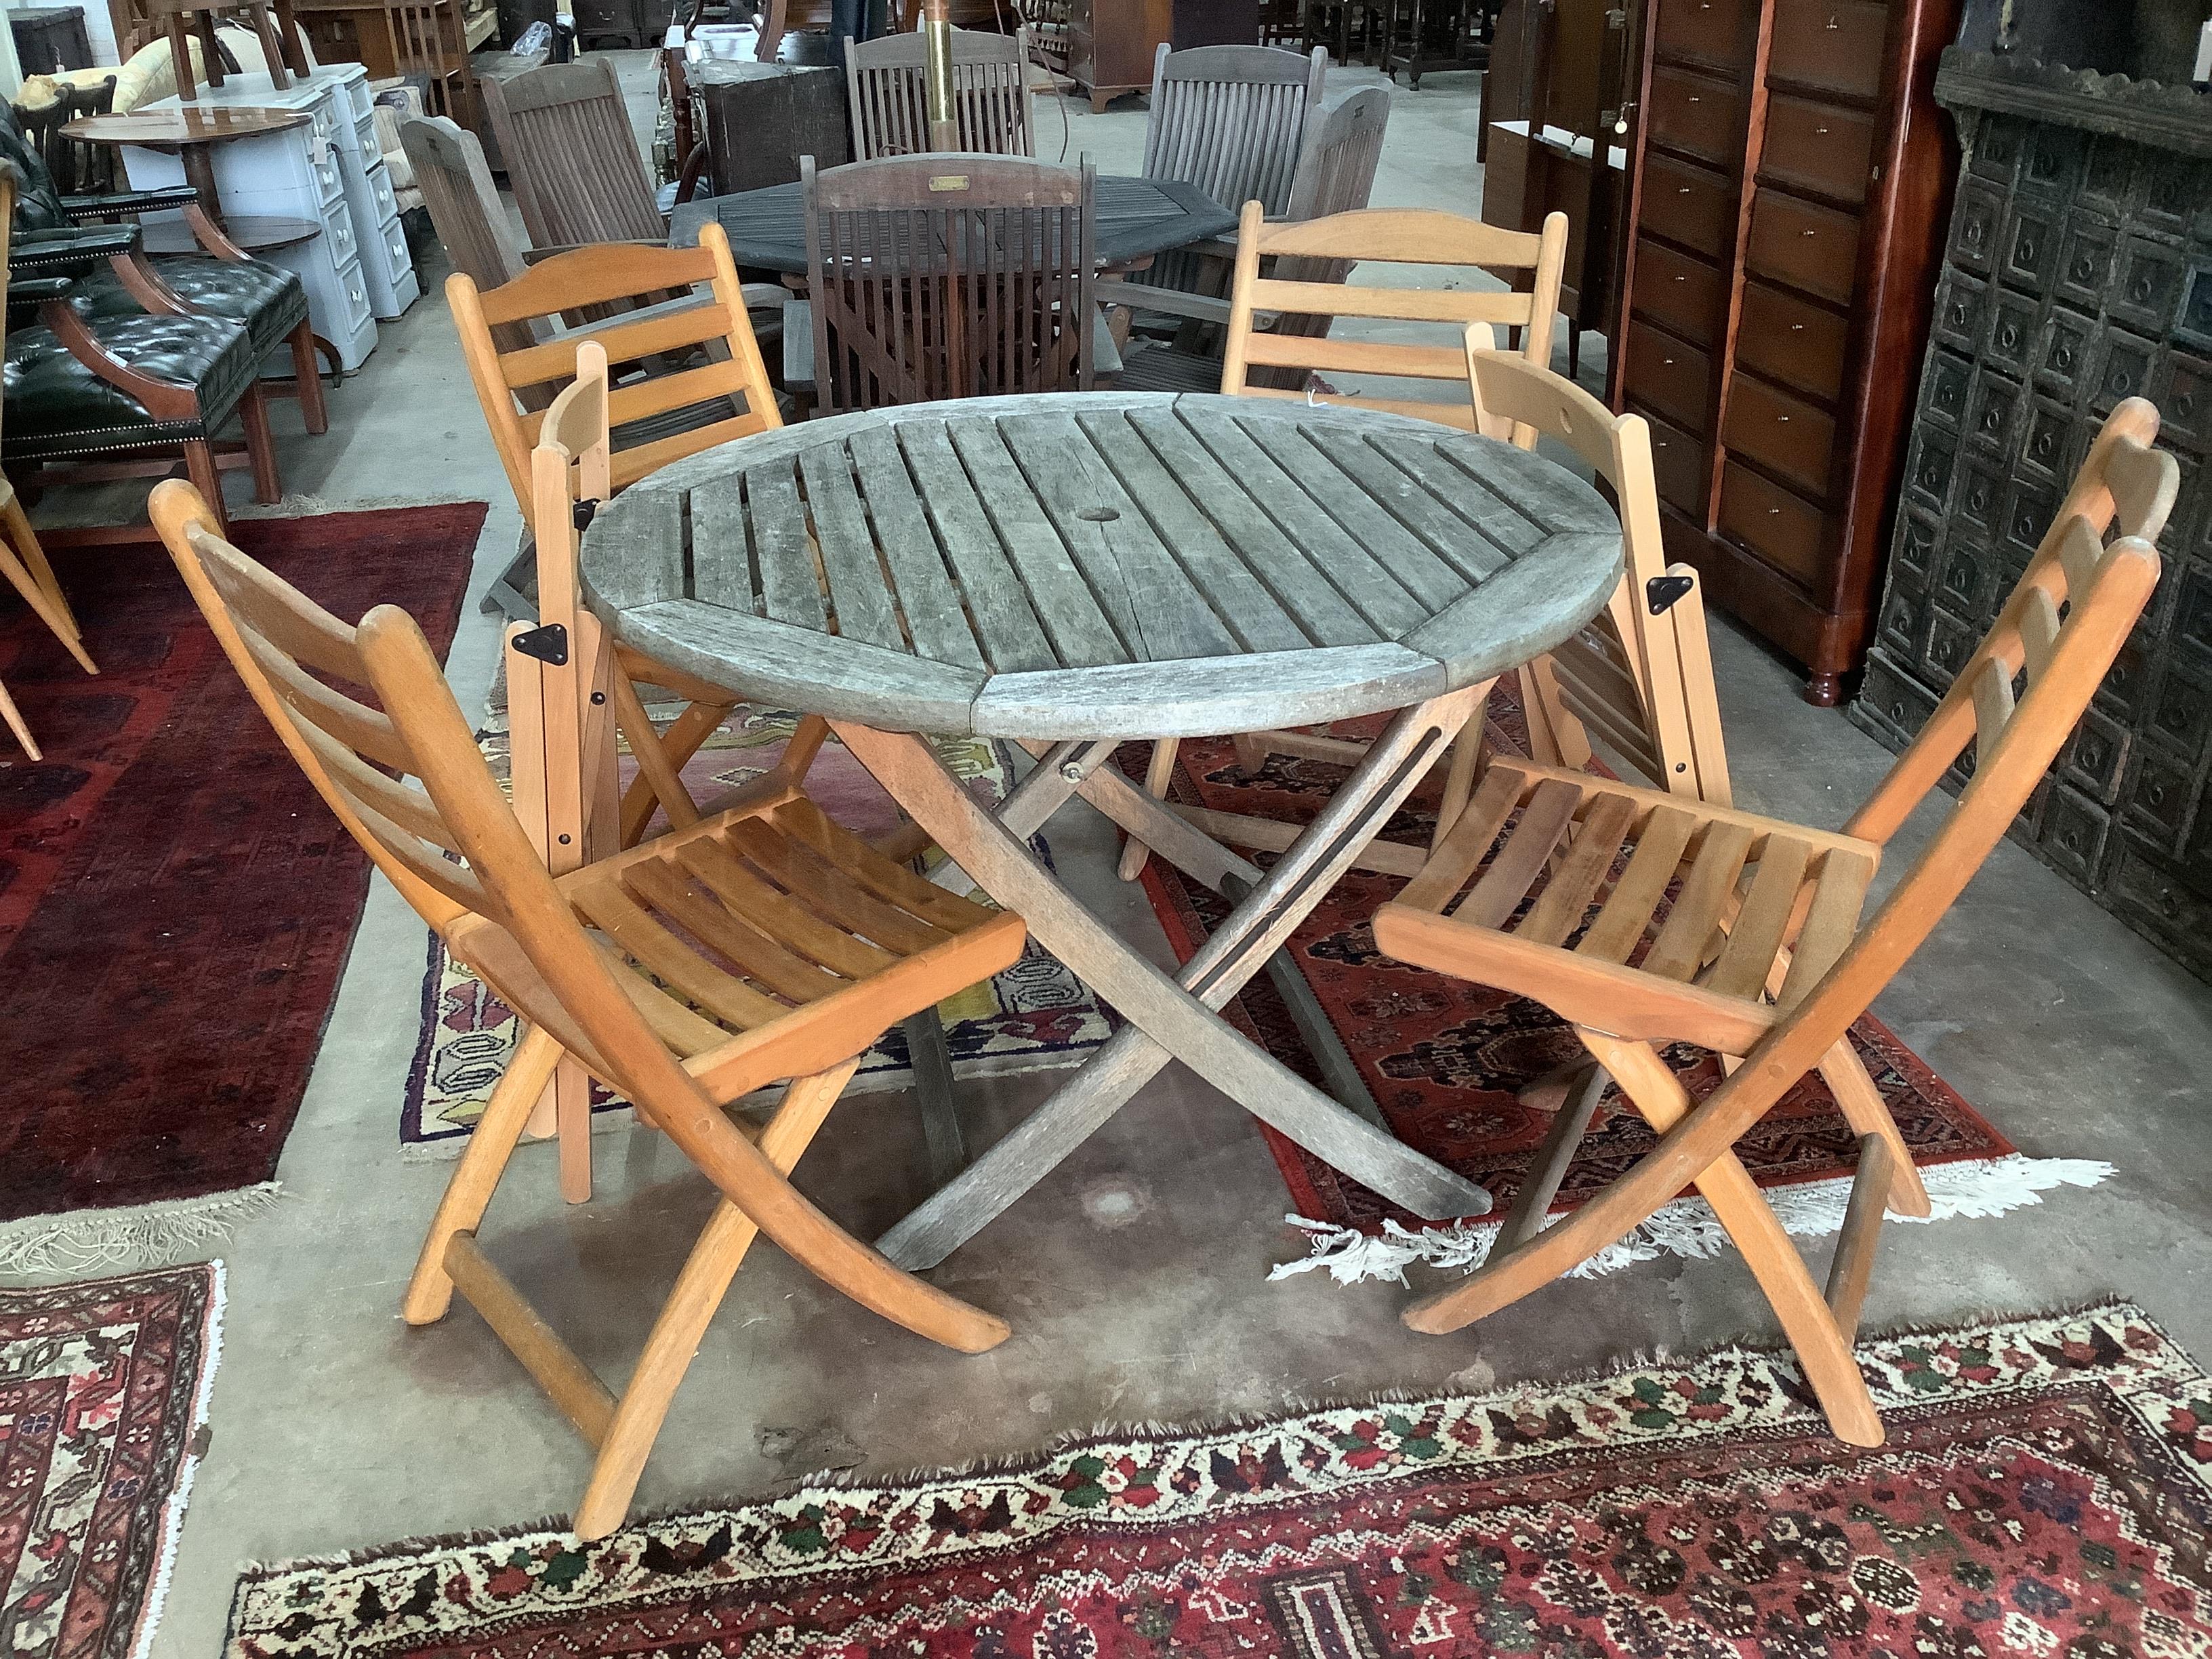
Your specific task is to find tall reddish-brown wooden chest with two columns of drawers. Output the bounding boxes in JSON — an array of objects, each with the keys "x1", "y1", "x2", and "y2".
[{"x1": 1610, "y1": 0, "x2": 1960, "y2": 703}]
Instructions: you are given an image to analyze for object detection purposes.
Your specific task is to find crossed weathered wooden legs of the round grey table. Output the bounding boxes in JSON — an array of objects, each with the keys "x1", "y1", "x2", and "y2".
[{"x1": 832, "y1": 684, "x2": 1491, "y2": 1270}]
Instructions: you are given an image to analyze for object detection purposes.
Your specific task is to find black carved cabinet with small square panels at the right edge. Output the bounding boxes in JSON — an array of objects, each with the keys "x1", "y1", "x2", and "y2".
[{"x1": 1853, "y1": 35, "x2": 2212, "y2": 978}]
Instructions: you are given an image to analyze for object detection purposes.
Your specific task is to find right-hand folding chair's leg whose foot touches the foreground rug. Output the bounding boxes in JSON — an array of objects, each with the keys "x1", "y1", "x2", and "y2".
[{"x1": 1577, "y1": 1026, "x2": 1883, "y2": 1447}]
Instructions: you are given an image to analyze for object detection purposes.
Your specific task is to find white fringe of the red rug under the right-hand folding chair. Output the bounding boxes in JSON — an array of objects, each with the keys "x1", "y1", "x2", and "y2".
[{"x1": 1267, "y1": 1153, "x2": 2112, "y2": 1285}]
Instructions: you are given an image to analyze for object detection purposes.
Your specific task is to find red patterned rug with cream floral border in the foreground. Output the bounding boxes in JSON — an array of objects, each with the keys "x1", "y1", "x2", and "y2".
[{"x1": 211, "y1": 1305, "x2": 2212, "y2": 1659}]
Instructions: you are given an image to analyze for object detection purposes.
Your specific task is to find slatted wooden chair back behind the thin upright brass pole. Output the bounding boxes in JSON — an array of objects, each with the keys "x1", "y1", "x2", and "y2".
[{"x1": 845, "y1": 28, "x2": 1038, "y2": 161}]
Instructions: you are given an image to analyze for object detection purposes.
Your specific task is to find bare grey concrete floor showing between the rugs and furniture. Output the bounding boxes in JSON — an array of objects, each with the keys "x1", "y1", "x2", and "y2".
[{"x1": 21, "y1": 48, "x2": 2212, "y2": 1659}]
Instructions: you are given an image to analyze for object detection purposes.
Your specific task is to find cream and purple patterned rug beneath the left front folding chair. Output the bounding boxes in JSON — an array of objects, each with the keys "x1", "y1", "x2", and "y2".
[{"x1": 401, "y1": 708, "x2": 1113, "y2": 1159}]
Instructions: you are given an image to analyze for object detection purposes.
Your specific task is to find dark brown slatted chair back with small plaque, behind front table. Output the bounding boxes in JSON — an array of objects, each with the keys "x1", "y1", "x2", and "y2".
[{"x1": 801, "y1": 155, "x2": 1097, "y2": 413}]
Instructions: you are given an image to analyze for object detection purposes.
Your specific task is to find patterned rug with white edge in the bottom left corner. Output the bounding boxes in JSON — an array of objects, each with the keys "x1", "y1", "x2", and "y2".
[{"x1": 0, "y1": 1263, "x2": 224, "y2": 1659}]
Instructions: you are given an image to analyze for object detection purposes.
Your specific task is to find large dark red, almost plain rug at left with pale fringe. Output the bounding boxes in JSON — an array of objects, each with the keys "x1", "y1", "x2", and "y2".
[{"x1": 0, "y1": 502, "x2": 485, "y2": 1267}]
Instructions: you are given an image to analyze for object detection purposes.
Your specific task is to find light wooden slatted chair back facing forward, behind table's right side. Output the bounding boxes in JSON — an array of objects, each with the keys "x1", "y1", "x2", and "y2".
[{"x1": 1221, "y1": 201, "x2": 1597, "y2": 436}]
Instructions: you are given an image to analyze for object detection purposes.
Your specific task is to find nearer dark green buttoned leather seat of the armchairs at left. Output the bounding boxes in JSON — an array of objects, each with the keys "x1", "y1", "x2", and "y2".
[{"x1": 0, "y1": 314, "x2": 261, "y2": 460}]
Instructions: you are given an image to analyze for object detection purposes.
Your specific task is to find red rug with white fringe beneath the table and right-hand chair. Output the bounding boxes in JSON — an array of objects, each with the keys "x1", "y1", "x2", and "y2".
[{"x1": 1120, "y1": 677, "x2": 2110, "y2": 1279}]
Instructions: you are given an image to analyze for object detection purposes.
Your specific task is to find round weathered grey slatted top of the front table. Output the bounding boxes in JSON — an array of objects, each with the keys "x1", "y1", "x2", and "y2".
[{"x1": 581, "y1": 392, "x2": 1622, "y2": 739}]
